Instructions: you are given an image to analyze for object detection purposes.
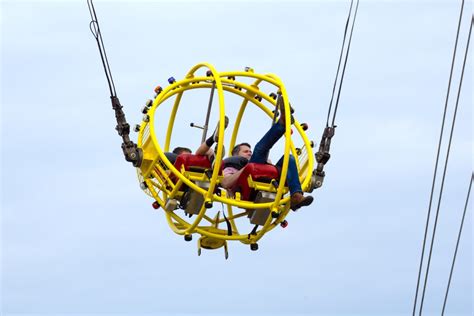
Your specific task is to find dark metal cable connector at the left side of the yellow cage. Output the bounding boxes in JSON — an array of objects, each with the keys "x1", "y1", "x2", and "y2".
[{"x1": 110, "y1": 96, "x2": 143, "y2": 168}]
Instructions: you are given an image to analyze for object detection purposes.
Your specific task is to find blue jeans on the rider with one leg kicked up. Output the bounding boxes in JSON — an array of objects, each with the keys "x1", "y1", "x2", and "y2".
[{"x1": 249, "y1": 123, "x2": 303, "y2": 195}]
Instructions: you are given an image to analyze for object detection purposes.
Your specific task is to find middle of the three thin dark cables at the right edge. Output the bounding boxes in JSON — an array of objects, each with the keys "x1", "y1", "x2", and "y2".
[{"x1": 420, "y1": 6, "x2": 466, "y2": 315}]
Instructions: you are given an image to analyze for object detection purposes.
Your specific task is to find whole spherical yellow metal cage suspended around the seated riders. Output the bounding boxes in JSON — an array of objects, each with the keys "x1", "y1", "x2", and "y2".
[{"x1": 137, "y1": 63, "x2": 314, "y2": 253}]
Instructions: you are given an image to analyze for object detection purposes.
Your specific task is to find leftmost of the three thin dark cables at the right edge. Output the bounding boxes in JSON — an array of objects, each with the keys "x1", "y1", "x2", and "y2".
[{"x1": 412, "y1": 0, "x2": 464, "y2": 316}]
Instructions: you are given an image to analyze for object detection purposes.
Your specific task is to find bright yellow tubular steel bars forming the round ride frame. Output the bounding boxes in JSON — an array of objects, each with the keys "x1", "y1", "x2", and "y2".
[{"x1": 137, "y1": 63, "x2": 314, "y2": 244}]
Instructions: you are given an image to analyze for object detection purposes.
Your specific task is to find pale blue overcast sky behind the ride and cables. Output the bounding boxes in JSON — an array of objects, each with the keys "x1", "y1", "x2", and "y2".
[{"x1": 0, "y1": 0, "x2": 473, "y2": 316}]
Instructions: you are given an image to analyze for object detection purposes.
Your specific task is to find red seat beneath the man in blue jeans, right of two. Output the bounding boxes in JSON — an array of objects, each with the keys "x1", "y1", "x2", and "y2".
[{"x1": 236, "y1": 163, "x2": 280, "y2": 201}]
